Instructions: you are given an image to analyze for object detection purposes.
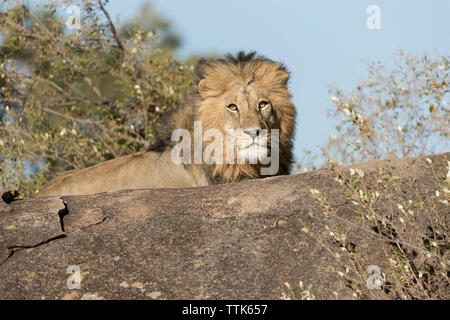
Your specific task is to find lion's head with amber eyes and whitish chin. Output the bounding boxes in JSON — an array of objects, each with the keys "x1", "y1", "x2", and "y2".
[{"x1": 197, "y1": 53, "x2": 295, "y2": 170}]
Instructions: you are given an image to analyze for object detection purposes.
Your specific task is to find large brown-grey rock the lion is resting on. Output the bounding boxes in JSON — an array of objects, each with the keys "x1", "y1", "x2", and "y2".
[{"x1": 0, "y1": 153, "x2": 450, "y2": 299}]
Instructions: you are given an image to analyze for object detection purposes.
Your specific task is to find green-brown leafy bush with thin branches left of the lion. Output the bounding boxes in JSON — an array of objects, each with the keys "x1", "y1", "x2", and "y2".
[{"x1": 0, "y1": 1, "x2": 191, "y2": 196}]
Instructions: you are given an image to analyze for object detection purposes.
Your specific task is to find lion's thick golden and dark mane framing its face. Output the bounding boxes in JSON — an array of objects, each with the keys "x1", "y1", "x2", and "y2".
[{"x1": 149, "y1": 52, "x2": 296, "y2": 183}]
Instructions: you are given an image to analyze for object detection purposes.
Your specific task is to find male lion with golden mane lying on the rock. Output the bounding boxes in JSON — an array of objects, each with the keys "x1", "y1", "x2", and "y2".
[{"x1": 38, "y1": 52, "x2": 296, "y2": 197}]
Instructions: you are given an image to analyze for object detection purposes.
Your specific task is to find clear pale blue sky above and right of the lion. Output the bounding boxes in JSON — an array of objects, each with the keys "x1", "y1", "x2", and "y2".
[{"x1": 74, "y1": 0, "x2": 450, "y2": 159}]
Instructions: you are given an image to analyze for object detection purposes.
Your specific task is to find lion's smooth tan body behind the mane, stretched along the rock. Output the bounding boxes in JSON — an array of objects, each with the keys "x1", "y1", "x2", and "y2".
[{"x1": 38, "y1": 150, "x2": 209, "y2": 197}]
